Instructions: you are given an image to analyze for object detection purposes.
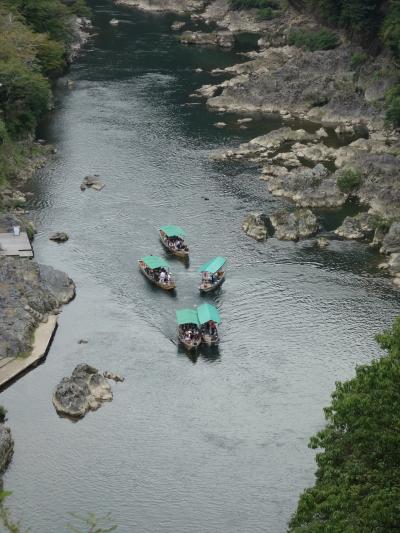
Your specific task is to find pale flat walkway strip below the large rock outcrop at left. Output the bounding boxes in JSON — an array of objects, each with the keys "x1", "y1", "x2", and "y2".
[{"x1": 0, "y1": 315, "x2": 57, "y2": 389}]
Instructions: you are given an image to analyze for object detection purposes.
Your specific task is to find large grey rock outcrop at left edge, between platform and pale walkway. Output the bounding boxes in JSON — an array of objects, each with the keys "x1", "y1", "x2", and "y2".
[{"x1": 0, "y1": 257, "x2": 75, "y2": 357}]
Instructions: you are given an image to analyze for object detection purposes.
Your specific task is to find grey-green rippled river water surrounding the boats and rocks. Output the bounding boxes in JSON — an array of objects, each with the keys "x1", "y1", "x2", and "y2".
[{"x1": 1, "y1": 0, "x2": 400, "y2": 533}]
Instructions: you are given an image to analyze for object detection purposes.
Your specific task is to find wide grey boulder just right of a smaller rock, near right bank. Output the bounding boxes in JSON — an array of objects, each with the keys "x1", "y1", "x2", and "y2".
[{"x1": 270, "y1": 209, "x2": 319, "y2": 241}]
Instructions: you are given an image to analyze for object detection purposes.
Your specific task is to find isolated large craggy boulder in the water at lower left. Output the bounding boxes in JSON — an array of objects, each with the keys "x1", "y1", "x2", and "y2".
[{"x1": 53, "y1": 363, "x2": 113, "y2": 418}]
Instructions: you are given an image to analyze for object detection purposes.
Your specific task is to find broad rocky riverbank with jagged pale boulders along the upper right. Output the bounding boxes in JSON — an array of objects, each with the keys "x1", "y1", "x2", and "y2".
[{"x1": 116, "y1": 0, "x2": 400, "y2": 286}]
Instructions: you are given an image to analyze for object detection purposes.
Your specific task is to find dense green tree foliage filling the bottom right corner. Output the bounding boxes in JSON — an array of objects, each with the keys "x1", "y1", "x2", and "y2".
[{"x1": 289, "y1": 317, "x2": 400, "y2": 533}]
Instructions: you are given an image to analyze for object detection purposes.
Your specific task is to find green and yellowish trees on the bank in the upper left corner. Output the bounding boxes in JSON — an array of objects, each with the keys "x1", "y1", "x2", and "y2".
[{"x1": 0, "y1": 0, "x2": 87, "y2": 184}]
